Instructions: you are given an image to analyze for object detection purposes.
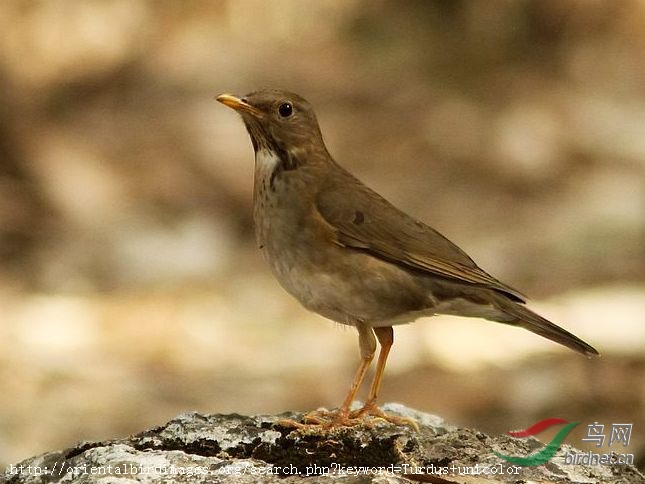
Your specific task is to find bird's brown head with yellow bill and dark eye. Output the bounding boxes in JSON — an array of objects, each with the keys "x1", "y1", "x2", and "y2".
[{"x1": 217, "y1": 89, "x2": 327, "y2": 167}]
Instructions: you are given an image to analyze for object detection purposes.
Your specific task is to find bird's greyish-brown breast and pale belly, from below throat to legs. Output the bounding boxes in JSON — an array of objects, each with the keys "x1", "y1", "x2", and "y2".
[{"x1": 254, "y1": 169, "x2": 434, "y2": 326}]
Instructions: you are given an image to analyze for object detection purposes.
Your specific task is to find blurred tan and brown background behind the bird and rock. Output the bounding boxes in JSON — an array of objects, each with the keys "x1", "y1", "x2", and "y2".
[{"x1": 0, "y1": 0, "x2": 645, "y2": 468}]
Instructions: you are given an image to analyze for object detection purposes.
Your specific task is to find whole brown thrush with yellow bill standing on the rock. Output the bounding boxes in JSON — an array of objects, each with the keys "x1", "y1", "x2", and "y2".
[{"x1": 216, "y1": 89, "x2": 599, "y2": 427}]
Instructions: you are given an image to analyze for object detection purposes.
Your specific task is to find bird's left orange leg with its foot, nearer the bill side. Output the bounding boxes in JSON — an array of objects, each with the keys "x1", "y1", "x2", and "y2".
[{"x1": 305, "y1": 322, "x2": 380, "y2": 426}]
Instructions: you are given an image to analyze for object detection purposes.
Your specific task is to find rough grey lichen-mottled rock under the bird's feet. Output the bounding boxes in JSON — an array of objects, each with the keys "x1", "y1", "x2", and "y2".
[{"x1": 0, "y1": 404, "x2": 645, "y2": 484}]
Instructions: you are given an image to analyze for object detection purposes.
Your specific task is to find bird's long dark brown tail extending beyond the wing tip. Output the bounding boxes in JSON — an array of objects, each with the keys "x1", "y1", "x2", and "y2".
[{"x1": 491, "y1": 295, "x2": 600, "y2": 358}]
